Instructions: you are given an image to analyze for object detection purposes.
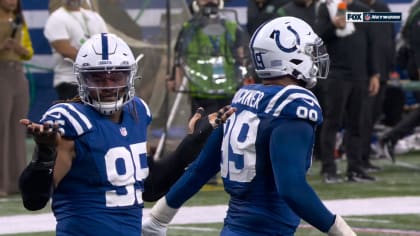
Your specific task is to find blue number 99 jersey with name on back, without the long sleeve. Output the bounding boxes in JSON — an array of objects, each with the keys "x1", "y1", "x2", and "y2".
[{"x1": 220, "y1": 84, "x2": 322, "y2": 235}]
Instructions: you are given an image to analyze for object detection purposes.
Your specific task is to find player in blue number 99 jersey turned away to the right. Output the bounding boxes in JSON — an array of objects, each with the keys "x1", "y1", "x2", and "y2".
[{"x1": 143, "y1": 17, "x2": 355, "y2": 236}]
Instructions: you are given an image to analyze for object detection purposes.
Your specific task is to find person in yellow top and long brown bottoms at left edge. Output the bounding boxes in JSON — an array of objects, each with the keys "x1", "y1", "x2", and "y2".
[{"x1": 0, "y1": 0, "x2": 33, "y2": 196}]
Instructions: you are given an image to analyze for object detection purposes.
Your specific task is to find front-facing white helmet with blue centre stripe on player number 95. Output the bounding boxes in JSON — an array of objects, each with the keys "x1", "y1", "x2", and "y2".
[{"x1": 74, "y1": 33, "x2": 137, "y2": 115}]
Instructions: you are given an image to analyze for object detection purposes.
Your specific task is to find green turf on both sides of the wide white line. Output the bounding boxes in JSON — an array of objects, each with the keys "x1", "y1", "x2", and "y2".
[{"x1": 0, "y1": 141, "x2": 420, "y2": 236}]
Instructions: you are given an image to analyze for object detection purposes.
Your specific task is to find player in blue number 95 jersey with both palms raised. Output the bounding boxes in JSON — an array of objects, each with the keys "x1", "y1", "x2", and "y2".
[{"x1": 19, "y1": 33, "x2": 234, "y2": 236}]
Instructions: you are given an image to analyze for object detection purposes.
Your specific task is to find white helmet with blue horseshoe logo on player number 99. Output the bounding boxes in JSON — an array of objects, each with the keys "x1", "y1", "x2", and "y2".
[{"x1": 249, "y1": 17, "x2": 330, "y2": 88}]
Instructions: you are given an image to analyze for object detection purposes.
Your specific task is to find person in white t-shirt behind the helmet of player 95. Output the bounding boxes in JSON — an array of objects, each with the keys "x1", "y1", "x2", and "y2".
[{"x1": 44, "y1": 0, "x2": 108, "y2": 100}]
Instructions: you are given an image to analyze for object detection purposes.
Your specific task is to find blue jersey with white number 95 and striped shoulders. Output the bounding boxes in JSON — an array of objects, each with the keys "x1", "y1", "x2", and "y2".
[{"x1": 41, "y1": 97, "x2": 151, "y2": 235}]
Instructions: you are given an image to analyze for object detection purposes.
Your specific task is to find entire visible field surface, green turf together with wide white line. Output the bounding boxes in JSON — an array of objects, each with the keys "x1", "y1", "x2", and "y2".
[{"x1": 0, "y1": 141, "x2": 420, "y2": 236}]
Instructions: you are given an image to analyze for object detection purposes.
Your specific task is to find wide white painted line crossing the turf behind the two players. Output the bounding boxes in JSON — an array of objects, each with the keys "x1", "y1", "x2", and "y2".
[{"x1": 0, "y1": 197, "x2": 420, "y2": 235}]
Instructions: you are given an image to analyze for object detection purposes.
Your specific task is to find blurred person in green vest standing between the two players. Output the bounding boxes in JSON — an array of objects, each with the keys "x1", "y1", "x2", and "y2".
[{"x1": 168, "y1": 0, "x2": 250, "y2": 117}]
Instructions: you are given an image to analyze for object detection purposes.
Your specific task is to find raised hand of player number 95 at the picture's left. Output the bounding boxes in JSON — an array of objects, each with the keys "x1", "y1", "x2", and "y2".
[{"x1": 19, "y1": 119, "x2": 61, "y2": 148}]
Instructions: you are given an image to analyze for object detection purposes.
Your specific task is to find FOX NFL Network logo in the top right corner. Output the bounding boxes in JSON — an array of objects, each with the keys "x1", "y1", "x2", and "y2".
[{"x1": 346, "y1": 12, "x2": 402, "y2": 22}]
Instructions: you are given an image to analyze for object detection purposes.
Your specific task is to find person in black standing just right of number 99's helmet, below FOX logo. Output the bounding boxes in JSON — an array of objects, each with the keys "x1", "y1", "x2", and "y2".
[{"x1": 316, "y1": 0, "x2": 380, "y2": 183}]
